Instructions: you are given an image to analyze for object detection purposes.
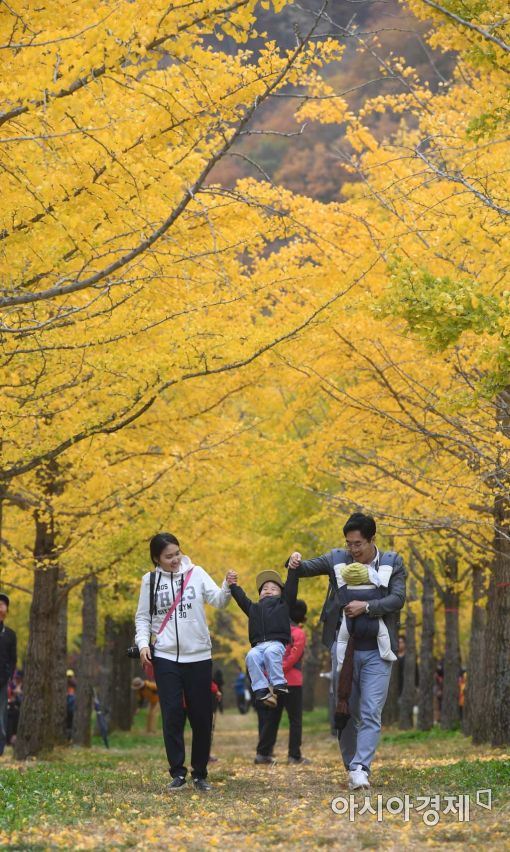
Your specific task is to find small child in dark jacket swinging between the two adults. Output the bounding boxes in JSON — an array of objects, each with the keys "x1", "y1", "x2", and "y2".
[{"x1": 226, "y1": 569, "x2": 298, "y2": 707}]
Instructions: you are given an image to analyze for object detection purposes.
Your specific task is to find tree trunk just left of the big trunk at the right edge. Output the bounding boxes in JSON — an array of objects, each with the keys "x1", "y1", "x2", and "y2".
[{"x1": 462, "y1": 565, "x2": 487, "y2": 743}]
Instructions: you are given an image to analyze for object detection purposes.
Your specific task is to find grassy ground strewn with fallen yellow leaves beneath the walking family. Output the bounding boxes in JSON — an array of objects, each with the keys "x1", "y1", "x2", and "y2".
[{"x1": 0, "y1": 709, "x2": 510, "y2": 850}]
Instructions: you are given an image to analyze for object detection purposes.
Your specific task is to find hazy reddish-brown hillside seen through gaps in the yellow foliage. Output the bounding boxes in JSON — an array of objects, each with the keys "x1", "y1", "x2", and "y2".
[{"x1": 211, "y1": 0, "x2": 454, "y2": 202}]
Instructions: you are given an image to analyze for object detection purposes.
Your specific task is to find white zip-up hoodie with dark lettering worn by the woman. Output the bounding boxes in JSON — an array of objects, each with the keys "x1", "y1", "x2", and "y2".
[{"x1": 135, "y1": 556, "x2": 230, "y2": 663}]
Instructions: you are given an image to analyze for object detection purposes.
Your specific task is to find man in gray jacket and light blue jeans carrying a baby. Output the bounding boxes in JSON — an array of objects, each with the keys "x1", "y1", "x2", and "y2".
[{"x1": 288, "y1": 512, "x2": 406, "y2": 790}]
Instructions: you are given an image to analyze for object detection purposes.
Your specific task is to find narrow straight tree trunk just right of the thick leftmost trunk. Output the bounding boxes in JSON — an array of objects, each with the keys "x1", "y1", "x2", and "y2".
[{"x1": 73, "y1": 577, "x2": 97, "y2": 747}]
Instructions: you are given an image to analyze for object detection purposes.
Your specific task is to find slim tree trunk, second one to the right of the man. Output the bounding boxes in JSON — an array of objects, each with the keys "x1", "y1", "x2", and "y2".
[{"x1": 418, "y1": 563, "x2": 436, "y2": 731}]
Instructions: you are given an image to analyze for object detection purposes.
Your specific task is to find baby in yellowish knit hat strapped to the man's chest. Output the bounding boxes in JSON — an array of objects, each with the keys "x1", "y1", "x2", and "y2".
[{"x1": 337, "y1": 562, "x2": 397, "y2": 670}]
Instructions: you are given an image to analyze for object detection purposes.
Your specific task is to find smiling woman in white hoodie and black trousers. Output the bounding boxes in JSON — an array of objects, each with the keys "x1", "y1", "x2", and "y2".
[{"x1": 135, "y1": 533, "x2": 230, "y2": 791}]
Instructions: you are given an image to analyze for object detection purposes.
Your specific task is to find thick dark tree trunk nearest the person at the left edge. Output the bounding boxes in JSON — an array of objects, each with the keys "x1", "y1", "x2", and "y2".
[{"x1": 15, "y1": 565, "x2": 58, "y2": 760}]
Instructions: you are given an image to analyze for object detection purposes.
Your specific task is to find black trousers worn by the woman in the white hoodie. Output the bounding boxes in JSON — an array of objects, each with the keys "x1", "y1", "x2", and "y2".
[{"x1": 154, "y1": 657, "x2": 212, "y2": 778}]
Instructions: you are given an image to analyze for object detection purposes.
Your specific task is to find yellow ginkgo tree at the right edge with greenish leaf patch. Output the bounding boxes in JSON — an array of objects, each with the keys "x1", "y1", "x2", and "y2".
[{"x1": 262, "y1": 0, "x2": 510, "y2": 744}]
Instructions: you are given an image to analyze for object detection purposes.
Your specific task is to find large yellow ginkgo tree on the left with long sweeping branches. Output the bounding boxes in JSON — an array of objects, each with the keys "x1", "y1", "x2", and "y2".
[{"x1": 0, "y1": 0, "x2": 362, "y2": 751}]
